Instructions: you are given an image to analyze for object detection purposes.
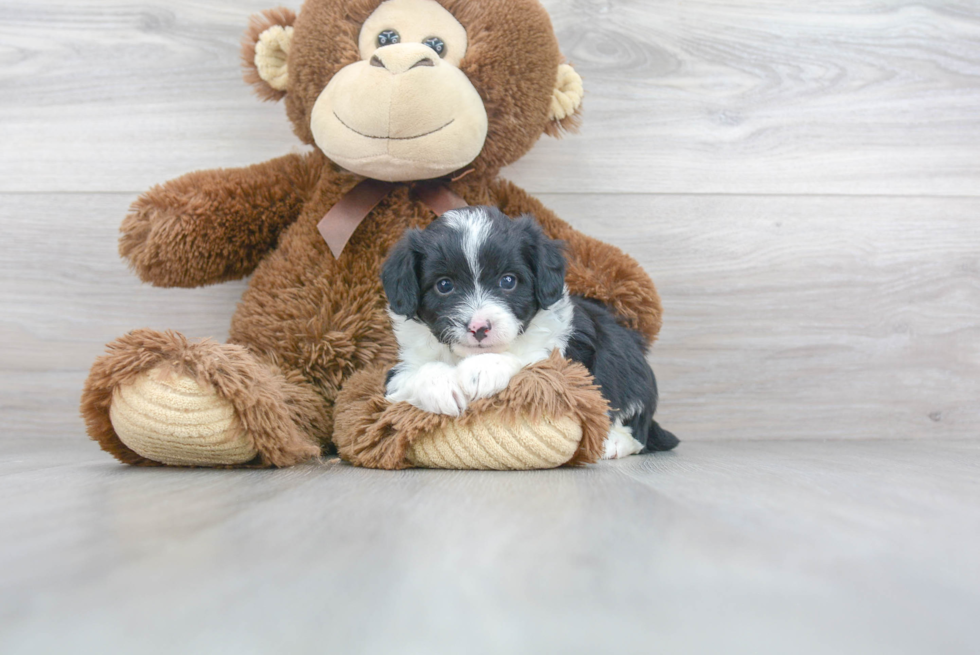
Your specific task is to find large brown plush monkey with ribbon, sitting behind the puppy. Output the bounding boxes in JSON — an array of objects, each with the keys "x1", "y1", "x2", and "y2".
[{"x1": 82, "y1": 0, "x2": 661, "y2": 468}]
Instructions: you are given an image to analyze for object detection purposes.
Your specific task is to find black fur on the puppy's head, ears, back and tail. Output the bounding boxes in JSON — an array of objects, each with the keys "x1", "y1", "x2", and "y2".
[{"x1": 381, "y1": 207, "x2": 678, "y2": 452}]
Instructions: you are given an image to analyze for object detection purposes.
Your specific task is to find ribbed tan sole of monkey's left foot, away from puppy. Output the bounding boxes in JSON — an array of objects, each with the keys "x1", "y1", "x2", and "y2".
[{"x1": 109, "y1": 369, "x2": 257, "y2": 466}]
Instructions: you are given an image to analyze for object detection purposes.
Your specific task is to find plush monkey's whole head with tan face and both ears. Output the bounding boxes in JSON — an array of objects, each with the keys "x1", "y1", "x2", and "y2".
[{"x1": 242, "y1": 0, "x2": 583, "y2": 181}]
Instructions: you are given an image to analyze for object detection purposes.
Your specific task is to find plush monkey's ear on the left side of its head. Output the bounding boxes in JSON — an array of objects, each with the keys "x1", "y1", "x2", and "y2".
[{"x1": 242, "y1": 7, "x2": 296, "y2": 100}]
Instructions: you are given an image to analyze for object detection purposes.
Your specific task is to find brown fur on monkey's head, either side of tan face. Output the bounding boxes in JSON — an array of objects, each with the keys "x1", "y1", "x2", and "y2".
[{"x1": 264, "y1": 0, "x2": 575, "y2": 172}]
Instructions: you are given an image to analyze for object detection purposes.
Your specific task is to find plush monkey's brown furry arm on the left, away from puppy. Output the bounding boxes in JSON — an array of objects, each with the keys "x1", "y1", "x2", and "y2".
[{"x1": 119, "y1": 153, "x2": 323, "y2": 287}]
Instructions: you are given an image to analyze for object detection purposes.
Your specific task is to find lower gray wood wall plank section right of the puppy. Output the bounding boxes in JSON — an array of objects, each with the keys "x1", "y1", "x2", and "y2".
[{"x1": 544, "y1": 195, "x2": 980, "y2": 439}]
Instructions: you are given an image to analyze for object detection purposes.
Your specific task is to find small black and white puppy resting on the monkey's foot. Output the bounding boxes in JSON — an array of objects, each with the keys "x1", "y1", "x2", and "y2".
[{"x1": 381, "y1": 207, "x2": 678, "y2": 459}]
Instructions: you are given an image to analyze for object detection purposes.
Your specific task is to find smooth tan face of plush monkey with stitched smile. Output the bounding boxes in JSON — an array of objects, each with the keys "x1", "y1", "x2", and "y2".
[{"x1": 310, "y1": 0, "x2": 487, "y2": 182}]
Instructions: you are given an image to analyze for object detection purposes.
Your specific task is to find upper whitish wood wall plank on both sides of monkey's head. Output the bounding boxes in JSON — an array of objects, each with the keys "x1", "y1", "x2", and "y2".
[{"x1": 0, "y1": 0, "x2": 980, "y2": 196}]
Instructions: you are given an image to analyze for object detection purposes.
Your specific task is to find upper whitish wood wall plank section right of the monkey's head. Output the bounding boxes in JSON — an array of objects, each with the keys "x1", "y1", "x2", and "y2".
[{"x1": 511, "y1": 0, "x2": 980, "y2": 196}]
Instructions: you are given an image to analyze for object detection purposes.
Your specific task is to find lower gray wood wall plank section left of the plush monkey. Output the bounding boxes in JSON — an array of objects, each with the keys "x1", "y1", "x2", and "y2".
[{"x1": 0, "y1": 194, "x2": 245, "y2": 438}]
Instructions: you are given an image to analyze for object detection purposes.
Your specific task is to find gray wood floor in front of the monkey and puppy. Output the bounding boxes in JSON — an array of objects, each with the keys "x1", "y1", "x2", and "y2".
[{"x1": 0, "y1": 439, "x2": 980, "y2": 655}]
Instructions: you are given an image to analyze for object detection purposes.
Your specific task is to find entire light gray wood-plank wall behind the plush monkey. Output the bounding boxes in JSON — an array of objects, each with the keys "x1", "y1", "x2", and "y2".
[{"x1": 0, "y1": 0, "x2": 980, "y2": 440}]
